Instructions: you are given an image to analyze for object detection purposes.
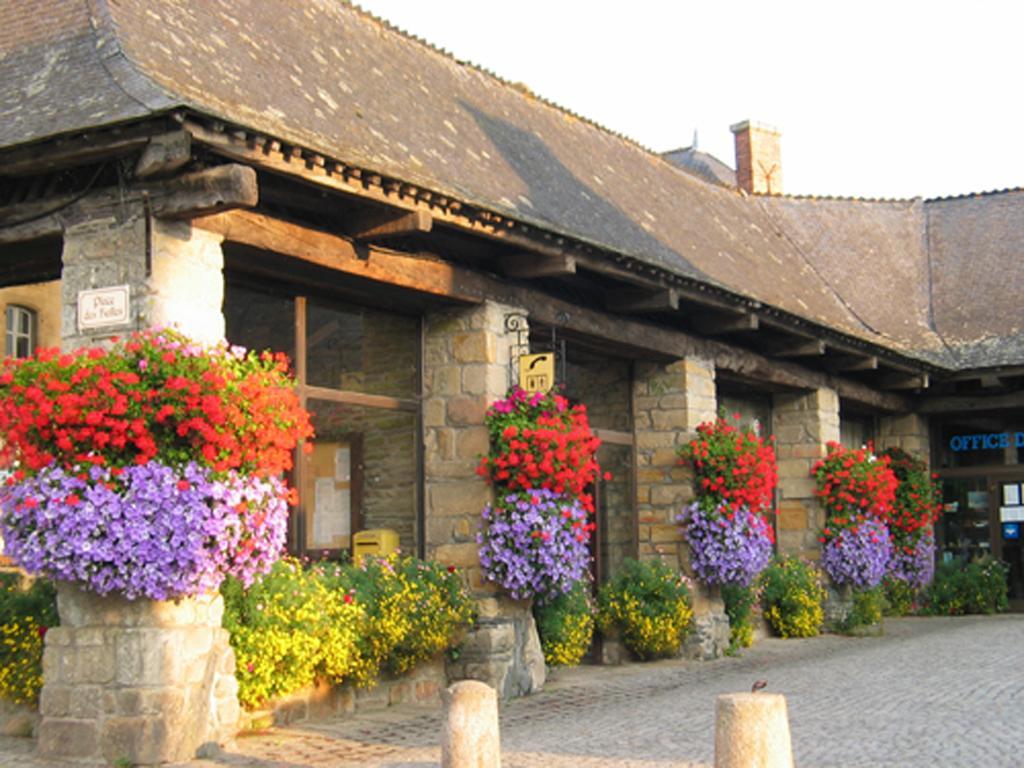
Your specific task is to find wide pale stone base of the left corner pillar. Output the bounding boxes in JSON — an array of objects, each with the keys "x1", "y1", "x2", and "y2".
[{"x1": 37, "y1": 584, "x2": 239, "y2": 765}]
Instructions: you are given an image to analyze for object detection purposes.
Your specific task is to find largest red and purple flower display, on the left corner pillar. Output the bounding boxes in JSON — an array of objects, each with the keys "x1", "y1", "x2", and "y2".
[{"x1": 0, "y1": 330, "x2": 312, "y2": 599}]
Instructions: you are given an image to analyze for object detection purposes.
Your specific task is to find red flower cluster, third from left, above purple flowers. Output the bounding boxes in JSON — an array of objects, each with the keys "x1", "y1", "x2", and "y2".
[{"x1": 679, "y1": 417, "x2": 778, "y2": 514}]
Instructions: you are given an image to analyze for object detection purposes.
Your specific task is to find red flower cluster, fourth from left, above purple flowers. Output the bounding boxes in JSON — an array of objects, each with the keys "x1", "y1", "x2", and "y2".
[{"x1": 811, "y1": 442, "x2": 898, "y2": 524}]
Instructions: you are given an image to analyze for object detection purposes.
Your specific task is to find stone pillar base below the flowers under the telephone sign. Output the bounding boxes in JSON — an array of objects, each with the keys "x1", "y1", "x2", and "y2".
[{"x1": 449, "y1": 597, "x2": 546, "y2": 699}]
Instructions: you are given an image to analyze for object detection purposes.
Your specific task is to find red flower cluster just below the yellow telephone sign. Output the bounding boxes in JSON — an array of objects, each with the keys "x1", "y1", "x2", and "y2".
[{"x1": 477, "y1": 388, "x2": 601, "y2": 513}]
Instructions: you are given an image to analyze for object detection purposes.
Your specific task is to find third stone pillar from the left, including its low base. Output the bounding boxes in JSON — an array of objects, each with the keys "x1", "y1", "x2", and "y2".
[{"x1": 633, "y1": 357, "x2": 729, "y2": 658}]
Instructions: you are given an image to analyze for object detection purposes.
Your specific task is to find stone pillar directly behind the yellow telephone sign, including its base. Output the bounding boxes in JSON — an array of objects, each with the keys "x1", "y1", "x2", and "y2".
[{"x1": 423, "y1": 301, "x2": 545, "y2": 698}]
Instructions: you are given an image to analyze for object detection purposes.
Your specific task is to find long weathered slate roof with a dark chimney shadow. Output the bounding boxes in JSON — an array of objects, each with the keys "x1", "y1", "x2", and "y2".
[{"x1": 0, "y1": 0, "x2": 1024, "y2": 366}]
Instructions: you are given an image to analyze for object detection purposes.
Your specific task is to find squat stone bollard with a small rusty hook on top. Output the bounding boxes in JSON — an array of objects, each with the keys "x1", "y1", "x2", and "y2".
[{"x1": 715, "y1": 693, "x2": 793, "y2": 768}]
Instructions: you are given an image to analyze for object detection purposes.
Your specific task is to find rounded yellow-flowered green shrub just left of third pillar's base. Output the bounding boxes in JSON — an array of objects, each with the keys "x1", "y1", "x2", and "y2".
[{"x1": 597, "y1": 558, "x2": 693, "y2": 659}]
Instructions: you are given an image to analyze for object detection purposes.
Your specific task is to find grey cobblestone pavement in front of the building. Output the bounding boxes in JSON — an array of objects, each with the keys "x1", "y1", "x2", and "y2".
[{"x1": 0, "y1": 614, "x2": 1024, "y2": 768}]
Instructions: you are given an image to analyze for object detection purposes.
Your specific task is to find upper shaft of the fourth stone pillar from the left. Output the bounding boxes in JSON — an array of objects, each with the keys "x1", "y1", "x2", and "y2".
[{"x1": 772, "y1": 389, "x2": 840, "y2": 559}]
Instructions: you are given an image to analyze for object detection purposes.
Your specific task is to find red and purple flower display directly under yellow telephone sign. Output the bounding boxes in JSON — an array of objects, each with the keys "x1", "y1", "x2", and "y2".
[{"x1": 477, "y1": 387, "x2": 600, "y2": 599}]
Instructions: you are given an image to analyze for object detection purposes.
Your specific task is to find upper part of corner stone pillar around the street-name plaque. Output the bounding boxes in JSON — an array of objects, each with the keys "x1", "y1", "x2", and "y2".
[{"x1": 61, "y1": 207, "x2": 224, "y2": 349}]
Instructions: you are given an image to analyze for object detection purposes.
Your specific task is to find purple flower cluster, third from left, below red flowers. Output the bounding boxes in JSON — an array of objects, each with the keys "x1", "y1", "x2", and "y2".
[{"x1": 676, "y1": 503, "x2": 772, "y2": 587}]
